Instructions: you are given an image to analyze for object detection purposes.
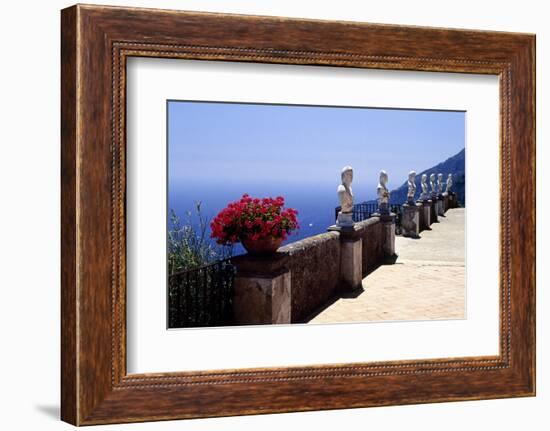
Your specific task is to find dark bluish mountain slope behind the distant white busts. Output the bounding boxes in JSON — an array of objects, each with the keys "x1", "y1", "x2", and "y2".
[{"x1": 390, "y1": 149, "x2": 466, "y2": 206}]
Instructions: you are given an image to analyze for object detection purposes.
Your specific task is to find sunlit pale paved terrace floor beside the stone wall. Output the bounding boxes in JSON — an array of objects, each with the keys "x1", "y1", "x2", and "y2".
[{"x1": 309, "y1": 208, "x2": 466, "y2": 323}]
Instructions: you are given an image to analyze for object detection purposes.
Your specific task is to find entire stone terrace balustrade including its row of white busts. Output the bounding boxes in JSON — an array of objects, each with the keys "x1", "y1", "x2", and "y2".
[{"x1": 232, "y1": 166, "x2": 458, "y2": 325}]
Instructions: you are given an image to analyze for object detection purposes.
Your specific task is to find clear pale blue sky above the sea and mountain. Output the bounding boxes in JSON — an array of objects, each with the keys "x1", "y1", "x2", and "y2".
[{"x1": 168, "y1": 101, "x2": 465, "y2": 200}]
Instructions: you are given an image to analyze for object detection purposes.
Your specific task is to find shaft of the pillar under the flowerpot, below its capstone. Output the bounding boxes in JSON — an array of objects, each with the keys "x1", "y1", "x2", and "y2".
[{"x1": 233, "y1": 270, "x2": 291, "y2": 325}]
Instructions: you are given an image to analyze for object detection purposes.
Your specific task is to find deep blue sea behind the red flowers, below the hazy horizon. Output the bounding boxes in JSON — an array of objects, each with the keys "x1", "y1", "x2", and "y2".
[{"x1": 168, "y1": 184, "x2": 380, "y2": 253}]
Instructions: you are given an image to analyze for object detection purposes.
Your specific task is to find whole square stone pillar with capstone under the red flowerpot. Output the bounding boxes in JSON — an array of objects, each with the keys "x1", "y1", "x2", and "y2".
[{"x1": 232, "y1": 253, "x2": 292, "y2": 325}]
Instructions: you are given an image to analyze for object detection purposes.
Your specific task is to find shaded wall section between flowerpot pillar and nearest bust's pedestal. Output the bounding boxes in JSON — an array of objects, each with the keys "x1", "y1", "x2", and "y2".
[{"x1": 279, "y1": 232, "x2": 340, "y2": 323}]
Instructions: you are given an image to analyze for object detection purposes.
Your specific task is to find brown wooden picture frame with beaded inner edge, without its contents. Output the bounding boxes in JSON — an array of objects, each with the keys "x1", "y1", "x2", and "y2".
[{"x1": 61, "y1": 5, "x2": 535, "y2": 425}]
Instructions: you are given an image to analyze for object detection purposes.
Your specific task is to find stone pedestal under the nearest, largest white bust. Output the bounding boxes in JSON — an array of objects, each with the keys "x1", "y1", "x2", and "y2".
[{"x1": 328, "y1": 225, "x2": 363, "y2": 292}]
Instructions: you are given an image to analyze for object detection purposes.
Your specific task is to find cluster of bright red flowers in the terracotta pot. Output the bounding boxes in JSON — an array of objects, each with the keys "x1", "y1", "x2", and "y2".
[{"x1": 210, "y1": 194, "x2": 298, "y2": 245}]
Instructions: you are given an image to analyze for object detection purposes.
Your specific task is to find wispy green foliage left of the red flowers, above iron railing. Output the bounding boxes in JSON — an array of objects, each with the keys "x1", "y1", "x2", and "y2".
[{"x1": 168, "y1": 202, "x2": 233, "y2": 274}]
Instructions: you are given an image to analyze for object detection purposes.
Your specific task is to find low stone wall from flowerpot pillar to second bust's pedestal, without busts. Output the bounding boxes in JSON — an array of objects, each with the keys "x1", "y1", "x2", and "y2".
[{"x1": 233, "y1": 215, "x2": 395, "y2": 324}]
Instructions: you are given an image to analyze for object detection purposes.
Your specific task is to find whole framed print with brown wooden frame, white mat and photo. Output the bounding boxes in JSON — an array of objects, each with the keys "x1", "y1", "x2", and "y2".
[{"x1": 61, "y1": 5, "x2": 535, "y2": 425}]
